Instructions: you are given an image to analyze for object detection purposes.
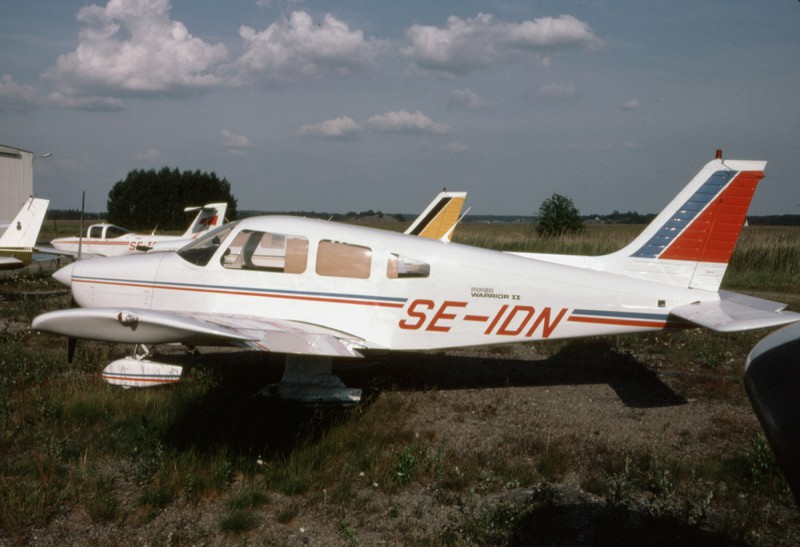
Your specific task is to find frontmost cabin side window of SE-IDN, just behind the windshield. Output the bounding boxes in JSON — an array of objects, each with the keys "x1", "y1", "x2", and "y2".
[{"x1": 222, "y1": 230, "x2": 308, "y2": 273}]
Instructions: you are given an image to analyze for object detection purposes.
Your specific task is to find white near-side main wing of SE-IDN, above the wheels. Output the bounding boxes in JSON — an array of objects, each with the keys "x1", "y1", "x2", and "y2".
[{"x1": 32, "y1": 308, "x2": 364, "y2": 357}]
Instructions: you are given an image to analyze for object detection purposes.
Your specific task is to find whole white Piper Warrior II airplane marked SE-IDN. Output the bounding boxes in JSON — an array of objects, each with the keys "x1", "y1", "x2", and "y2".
[{"x1": 33, "y1": 154, "x2": 800, "y2": 402}]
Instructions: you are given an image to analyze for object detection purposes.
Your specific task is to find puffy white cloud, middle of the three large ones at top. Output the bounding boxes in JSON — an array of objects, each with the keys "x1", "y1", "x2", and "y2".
[{"x1": 235, "y1": 11, "x2": 384, "y2": 81}]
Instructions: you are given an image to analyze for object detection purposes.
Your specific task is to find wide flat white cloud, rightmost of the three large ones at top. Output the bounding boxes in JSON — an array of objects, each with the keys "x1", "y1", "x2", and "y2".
[{"x1": 402, "y1": 13, "x2": 601, "y2": 75}]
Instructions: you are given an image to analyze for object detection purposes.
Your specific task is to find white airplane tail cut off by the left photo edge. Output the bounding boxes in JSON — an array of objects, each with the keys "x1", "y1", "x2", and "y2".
[{"x1": 0, "y1": 197, "x2": 50, "y2": 270}]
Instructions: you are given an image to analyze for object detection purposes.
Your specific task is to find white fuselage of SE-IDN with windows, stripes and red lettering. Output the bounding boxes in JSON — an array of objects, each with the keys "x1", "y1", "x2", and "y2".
[{"x1": 65, "y1": 216, "x2": 718, "y2": 350}]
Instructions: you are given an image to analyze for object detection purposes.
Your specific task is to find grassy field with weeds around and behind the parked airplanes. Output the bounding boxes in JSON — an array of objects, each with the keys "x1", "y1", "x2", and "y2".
[{"x1": 0, "y1": 223, "x2": 800, "y2": 545}]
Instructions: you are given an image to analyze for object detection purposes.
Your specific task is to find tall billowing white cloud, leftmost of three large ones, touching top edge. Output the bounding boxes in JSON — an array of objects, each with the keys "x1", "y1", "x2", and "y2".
[{"x1": 46, "y1": 0, "x2": 228, "y2": 96}]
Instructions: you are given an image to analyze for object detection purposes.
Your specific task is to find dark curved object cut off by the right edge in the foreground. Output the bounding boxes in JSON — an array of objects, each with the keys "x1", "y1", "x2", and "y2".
[{"x1": 744, "y1": 323, "x2": 800, "y2": 505}]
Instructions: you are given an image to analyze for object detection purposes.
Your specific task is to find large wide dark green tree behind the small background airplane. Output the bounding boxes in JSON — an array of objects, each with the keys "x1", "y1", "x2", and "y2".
[{"x1": 107, "y1": 167, "x2": 236, "y2": 230}]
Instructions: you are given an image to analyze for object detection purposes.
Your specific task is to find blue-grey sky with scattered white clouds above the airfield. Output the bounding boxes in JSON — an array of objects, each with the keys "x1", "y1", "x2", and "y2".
[{"x1": 0, "y1": 0, "x2": 800, "y2": 215}]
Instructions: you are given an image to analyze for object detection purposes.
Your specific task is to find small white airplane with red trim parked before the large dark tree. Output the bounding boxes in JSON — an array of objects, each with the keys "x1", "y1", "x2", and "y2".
[{"x1": 47, "y1": 203, "x2": 228, "y2": 257}]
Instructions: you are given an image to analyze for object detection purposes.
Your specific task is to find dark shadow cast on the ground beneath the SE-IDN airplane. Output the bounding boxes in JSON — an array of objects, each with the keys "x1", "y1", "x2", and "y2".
[{"x1": 159, "y1": 341, "x2": 687, "y2": 456}]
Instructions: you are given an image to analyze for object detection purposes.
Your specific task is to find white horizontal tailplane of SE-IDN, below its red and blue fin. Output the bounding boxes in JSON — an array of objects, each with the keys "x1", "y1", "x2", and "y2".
[{"x1": 670, "y1": 291, "x2": 800, "y2": 332}]
